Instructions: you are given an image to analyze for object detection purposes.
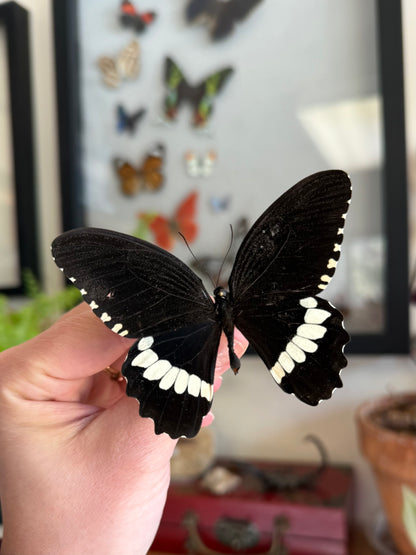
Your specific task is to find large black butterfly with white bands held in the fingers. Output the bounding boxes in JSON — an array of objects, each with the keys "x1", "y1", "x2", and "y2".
[{"x1": 52, "y1": 170, "x2": 351, "y2": 438}]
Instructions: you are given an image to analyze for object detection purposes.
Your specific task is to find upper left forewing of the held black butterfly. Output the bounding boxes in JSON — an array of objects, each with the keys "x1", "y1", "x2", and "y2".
[{"x1": 52, "y1": 228, "x2": 215, "y2": 337}]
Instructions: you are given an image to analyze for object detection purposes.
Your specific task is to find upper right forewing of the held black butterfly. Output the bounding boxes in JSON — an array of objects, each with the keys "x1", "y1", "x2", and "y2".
[{"x1": 229, "y1": 170, "x2": 351, "y2": 304}]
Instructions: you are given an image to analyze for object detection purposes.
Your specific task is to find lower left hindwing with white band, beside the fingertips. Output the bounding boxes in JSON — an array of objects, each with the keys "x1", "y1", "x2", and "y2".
[{"x1": 123, "y1": 320, "x2": 221, "y2": 438}]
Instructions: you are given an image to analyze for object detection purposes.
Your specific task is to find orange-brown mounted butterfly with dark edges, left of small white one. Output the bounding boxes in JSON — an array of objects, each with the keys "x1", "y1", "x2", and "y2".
[{"x1": 114, "y1": 144, "x2": 165, "y2": 196}]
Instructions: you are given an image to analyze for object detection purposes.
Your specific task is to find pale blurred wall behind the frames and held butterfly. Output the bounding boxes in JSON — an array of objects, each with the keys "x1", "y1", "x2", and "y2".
[{"x1": 1, "y1": 0, "x2": 416, "y2": 532}]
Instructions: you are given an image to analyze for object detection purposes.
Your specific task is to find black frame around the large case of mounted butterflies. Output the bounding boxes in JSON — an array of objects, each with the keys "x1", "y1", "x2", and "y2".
[{"x1": 53, "y1": 0, "x2": 410, "y2": 354}]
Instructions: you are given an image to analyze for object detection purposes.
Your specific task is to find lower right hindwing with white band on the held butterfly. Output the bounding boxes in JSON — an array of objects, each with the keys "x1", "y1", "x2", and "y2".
[{"x1": 236, "y1": 296, "x2": 349, "y2": 405}]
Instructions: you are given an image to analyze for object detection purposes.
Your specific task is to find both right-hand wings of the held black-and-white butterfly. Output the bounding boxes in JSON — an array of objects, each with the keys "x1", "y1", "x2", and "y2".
[{"x1": 229, "y1": 170, "x2": 351, "y2": 405}]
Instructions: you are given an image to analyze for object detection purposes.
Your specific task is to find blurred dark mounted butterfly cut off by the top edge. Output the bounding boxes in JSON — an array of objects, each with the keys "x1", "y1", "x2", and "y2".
[{"x1": 185, "y1": 0, "x2": 262, "y2": 40}]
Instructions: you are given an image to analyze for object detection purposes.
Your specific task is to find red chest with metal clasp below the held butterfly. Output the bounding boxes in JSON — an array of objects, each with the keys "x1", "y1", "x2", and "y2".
[{"x1": 152, "y1": 461, "x2": 352, "y2": 555}]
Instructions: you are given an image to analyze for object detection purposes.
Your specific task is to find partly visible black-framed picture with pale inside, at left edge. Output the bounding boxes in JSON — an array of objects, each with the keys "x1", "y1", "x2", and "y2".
[{"x1": 0, "y1": 2, "x2": 38, "y2": 295}]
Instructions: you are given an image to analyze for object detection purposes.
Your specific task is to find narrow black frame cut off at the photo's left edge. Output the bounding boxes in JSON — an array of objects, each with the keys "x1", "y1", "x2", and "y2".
[{"x1": 0, "y1": 2, "x2": 40, "y2": 295}]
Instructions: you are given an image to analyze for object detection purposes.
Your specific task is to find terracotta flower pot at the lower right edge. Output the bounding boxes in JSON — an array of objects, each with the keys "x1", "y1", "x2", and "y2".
[{"x1": 357, "y1": 393, "x2": 416, "y2": 555}]
